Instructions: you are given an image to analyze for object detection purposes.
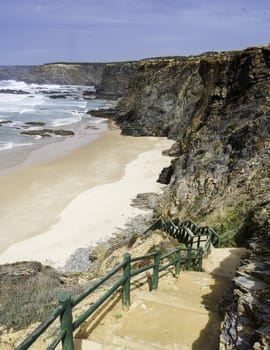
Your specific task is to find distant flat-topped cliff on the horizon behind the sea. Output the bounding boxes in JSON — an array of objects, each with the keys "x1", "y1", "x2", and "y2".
[{"x1": 0, "y1": 62, "x2": 137, "y2": 98}]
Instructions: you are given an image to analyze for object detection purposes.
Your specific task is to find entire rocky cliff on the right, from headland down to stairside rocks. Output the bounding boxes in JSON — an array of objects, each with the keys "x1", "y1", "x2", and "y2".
[{"x1": 112, "y1": 46, "x2": 270, "y2": 350}]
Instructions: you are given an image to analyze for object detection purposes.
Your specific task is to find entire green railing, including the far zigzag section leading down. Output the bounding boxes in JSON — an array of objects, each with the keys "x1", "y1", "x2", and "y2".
[{"x1": 15, "y1": 218, "x2": 219, "y2": 350}]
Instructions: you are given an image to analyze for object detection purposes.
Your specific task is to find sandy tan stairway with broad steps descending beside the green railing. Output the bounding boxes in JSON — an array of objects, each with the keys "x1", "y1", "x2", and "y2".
[{"x1": 75, "y1": 248, "x2": 245, "y2": 350}]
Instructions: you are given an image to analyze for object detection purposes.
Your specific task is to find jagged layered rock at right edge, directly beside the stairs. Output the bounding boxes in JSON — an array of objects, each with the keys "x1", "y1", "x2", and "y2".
[{"x1": 220, "y1": 202, "x2": 270, "y2": 350}]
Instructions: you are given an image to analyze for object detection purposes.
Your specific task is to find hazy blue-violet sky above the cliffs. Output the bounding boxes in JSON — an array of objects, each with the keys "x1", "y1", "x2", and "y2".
[{"x1": 0, "y1": 0, "x2": 270, "y2": 65}]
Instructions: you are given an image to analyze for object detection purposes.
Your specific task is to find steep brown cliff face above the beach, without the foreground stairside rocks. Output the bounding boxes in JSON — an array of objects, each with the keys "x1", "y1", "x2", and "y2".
[{"x1": 116, "y1": 46, "x2": 270, "y2": 235}]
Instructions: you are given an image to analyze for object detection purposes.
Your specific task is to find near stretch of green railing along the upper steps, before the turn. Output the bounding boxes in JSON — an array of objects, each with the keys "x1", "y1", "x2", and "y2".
[{"x1": 16, "y1": 246, "x2": 203, "y2": 350}]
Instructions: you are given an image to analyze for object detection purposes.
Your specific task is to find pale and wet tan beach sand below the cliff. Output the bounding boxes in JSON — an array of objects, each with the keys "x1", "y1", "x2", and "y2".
[{"x1": 0, "y1": 127, "x2": 172, "y2": 267}]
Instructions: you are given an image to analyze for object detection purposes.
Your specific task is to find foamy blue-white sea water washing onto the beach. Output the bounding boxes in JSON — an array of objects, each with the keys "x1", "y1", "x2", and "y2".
[{"x1": 0, "y1": 80, "x2": 111, "y2": 170}]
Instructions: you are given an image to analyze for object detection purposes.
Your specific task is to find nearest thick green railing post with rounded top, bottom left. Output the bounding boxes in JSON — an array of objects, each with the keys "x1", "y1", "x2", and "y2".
[{"x1": 59, "y1": 291, "x2": 74, "y2": 350}]
